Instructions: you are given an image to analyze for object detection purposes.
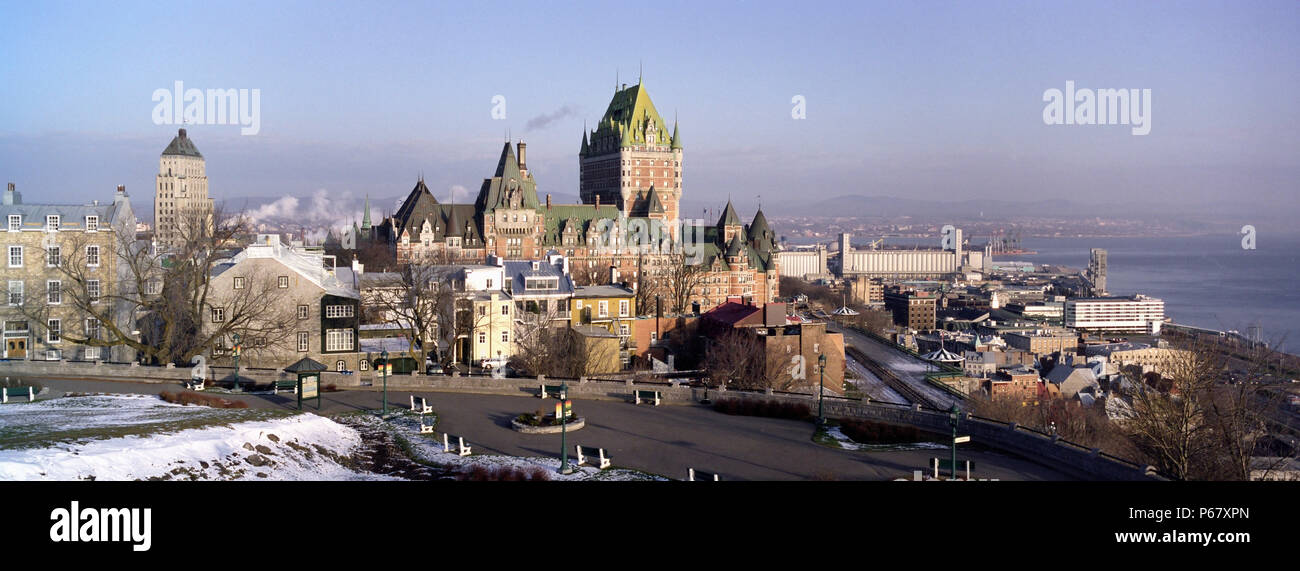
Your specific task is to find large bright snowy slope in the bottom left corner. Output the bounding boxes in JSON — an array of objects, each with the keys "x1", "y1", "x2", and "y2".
[{"x1": 0, "y1": 395, "x2": 390, "y2": 480}]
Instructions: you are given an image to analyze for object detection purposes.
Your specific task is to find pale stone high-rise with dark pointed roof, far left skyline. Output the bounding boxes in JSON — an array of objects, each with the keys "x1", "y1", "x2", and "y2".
[{"x1": 153, "y1": 129, "x2": 212, "y2": 247}]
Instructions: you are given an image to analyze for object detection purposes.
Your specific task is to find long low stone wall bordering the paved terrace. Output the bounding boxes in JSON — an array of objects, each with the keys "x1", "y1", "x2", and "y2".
[{"x1": 0, "y1": 360, "x2": 1161, "y2": 480}]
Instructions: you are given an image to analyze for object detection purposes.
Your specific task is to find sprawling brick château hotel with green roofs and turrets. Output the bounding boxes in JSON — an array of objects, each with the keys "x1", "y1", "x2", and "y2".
[{"x1": 371, "y1": 83, "x2": 779, "y2": 310}]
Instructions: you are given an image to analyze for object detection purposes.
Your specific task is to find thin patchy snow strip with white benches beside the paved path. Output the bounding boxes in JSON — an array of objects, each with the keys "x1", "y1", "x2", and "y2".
[{"x1": 359, "y1": 412, "x2": 667, "y2": 481}]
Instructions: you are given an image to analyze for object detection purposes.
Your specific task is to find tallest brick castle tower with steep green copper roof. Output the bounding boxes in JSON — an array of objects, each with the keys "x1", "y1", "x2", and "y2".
[{"x1": 579, "y1": 82, "x2": 683, "y2": 238}]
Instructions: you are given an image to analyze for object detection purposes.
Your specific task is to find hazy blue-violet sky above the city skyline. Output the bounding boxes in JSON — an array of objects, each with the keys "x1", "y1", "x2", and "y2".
[{"x1": 0, "y1": 1, "x2": 1300, "y2": 221}]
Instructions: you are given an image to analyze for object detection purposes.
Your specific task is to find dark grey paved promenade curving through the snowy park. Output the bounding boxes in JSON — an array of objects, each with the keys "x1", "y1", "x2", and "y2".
[{"x1": 22, "y1": 380, "x2": 1070, "y2": 480}]
